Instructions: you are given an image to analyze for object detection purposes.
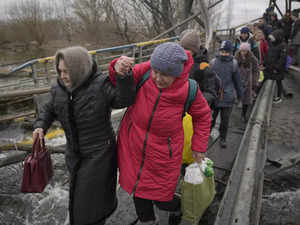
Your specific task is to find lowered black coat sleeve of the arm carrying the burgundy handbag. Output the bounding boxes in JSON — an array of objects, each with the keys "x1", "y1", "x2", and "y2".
[{"x1": 33, "y1": 86, "x2": 56, "y2": 134}]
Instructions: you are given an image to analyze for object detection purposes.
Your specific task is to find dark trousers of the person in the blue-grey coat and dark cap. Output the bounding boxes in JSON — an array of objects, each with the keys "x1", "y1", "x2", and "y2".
[{"x1": 211, "y1": 107, "x2": 232, "y2": 140}]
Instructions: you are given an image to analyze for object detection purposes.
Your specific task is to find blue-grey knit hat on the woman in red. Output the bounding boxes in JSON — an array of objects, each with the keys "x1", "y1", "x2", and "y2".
[{"x1": 150, "y1": 42, "x2": 188, "y2": 77}]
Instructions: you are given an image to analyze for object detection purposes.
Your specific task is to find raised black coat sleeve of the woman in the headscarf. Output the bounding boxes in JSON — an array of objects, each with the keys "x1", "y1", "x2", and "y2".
[{"x1": 103, "y1": 71, "x2": 136, "y2": 109}]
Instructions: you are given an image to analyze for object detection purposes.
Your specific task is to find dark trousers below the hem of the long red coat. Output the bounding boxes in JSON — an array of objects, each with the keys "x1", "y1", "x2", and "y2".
[{"x1": 133, "y1": 195, "x2": 181, "y2": 222}]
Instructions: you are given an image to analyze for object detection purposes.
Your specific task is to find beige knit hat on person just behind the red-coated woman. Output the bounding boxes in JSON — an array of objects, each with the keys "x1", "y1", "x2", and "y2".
[{"x1": 179, "y1": 30, "x2": 201, "y2": 53}]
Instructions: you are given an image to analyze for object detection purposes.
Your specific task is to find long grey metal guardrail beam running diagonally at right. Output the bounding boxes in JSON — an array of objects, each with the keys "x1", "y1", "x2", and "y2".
[{"x1": 214, "y1": 80, "x2": 274, "y2": 225}]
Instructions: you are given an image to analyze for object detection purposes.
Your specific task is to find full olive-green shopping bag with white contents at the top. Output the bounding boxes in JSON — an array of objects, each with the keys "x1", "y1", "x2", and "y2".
[{"x1": 181, "y1": 158, "x2": 216, "y2": 224}]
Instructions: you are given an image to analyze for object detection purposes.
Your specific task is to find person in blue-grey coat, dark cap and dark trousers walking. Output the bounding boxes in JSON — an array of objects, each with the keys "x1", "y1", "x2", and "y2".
[{"x1": 210, "y1": 40, "x2": 242, "y2": 148}]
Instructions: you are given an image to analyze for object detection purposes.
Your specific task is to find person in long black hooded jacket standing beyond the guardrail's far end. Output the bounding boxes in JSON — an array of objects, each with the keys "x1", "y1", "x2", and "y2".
[{"x1": 263, "y1": 29, "x2": 287, "y2": 103}]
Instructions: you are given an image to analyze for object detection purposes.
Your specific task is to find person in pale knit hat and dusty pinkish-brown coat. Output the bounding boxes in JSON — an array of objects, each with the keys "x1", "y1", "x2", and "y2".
[{"x1": 235, "y1": 43, "x2": 259, "y2": 122}]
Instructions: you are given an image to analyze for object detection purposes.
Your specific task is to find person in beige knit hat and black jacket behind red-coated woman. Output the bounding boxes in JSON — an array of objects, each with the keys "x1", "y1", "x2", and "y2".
[{"x1": 180, "y1": 30, "x2": 217, "y2": 107}]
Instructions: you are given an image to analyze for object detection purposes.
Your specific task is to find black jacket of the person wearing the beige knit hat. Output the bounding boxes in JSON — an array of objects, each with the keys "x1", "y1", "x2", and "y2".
[{"x1": 190, "y1": 54, "x2": 217, "y2": 106}]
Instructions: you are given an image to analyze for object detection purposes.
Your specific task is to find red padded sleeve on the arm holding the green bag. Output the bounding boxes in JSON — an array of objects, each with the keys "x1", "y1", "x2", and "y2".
[{"x1": 189, "y1": 90, "x2": 211, "y2": 152}]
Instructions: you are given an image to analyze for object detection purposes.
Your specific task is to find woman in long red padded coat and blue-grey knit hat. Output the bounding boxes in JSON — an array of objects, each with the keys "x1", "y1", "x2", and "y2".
[{"x1": 109, "y1": 42, "x2": 211, "y2": 225}]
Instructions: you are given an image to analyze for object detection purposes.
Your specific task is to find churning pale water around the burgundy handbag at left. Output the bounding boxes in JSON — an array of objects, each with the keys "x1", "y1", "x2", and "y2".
[{"x1": 0, "y1": 115, "x2": 123, "y2": 225}]
